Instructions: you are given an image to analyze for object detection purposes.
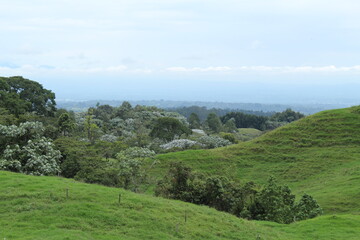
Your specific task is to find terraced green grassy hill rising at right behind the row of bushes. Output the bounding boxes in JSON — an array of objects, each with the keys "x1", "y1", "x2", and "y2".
[{"x1": 152, "y1": 107, "x2": 360, "y2": 214}]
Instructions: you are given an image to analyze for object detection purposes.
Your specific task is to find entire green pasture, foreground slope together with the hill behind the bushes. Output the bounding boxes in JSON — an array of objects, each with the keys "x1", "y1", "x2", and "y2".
[{"x1": 0, "y1": 107, "x2": 360, "y2": 240}]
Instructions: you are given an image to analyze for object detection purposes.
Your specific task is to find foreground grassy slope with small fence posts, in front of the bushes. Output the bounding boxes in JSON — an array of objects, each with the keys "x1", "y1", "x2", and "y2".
[{"x1": 0, "y1": 171, "x2": 360, "y2": 240}]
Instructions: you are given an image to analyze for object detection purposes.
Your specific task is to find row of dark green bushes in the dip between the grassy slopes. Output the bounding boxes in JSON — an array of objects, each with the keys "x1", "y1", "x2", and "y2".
[{"x1": 155, "y1": 162, "x2": 322, "y2": 223}]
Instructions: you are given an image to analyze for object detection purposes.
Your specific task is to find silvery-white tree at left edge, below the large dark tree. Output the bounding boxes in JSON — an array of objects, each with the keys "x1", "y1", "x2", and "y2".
[{"x1": 0, "y1": 122, "x2": 61, "y2": 175}]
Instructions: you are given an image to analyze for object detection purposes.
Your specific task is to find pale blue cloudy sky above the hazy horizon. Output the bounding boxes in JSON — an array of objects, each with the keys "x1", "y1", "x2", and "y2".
[{"x1": 0, "y1": 0, "x2": 360, "y2": 104}]
